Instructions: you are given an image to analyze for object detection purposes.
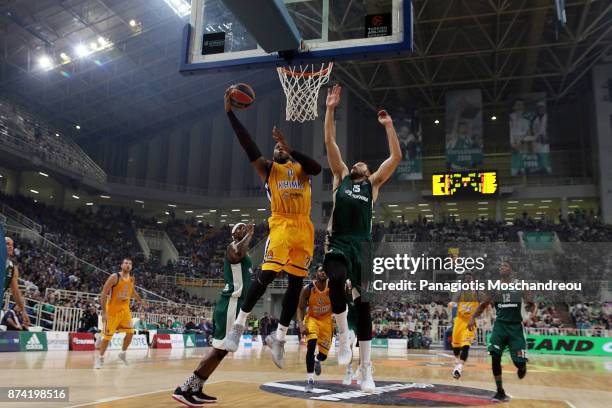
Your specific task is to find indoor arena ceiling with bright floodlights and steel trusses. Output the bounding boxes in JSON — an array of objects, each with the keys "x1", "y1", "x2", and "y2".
[{"x1": 0, "y1": 0, "x2": 612, "y2": 144}]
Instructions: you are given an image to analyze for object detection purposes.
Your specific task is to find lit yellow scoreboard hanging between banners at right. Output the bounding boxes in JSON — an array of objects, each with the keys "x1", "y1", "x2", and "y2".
[{"x1": 431, "y1": 170, "x2": 497, "y2": 198}]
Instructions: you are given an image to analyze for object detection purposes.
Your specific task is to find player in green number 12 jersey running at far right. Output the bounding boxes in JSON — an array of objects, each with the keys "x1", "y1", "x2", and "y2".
[{"x1": 468, "y1": 261, "x2": 536, "y2": 401}]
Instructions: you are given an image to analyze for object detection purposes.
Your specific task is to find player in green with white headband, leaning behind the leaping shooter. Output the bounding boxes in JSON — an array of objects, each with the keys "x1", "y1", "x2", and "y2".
[{"x1": 172, "y1": 223, "x2": 254, "y2": 407}]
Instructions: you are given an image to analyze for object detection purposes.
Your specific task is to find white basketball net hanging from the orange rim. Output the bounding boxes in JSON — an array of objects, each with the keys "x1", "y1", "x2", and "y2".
[{"x1": 276, "y1": 62, "x2": 334, "y2": 123}]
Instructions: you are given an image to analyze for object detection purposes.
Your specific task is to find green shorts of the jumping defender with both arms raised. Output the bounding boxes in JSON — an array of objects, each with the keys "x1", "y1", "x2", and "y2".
[{"x1": 323, "y1": 235, "x2": 367, "y2": 292}]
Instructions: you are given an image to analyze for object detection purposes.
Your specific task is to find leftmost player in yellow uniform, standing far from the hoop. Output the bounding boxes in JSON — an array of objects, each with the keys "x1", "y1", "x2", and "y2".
[{"x1": 94, "y1": 258, "x2": 145, "y2": 368}]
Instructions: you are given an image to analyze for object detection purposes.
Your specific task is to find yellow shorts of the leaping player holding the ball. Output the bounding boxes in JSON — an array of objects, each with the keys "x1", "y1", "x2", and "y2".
[{"x1": 261, "y1": 215, "x2": 314, "y2": 276}]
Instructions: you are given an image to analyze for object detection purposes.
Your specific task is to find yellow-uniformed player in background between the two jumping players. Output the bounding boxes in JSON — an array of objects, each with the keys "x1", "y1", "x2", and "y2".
[{"x1": 297, "y1": 265, "x2": 333, "y2": 392}]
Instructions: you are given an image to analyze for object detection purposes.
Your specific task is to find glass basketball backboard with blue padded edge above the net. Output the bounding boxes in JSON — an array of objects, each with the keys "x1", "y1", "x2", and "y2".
[{"x1": 180, "y1": 0, "x2": 413, "y2": 74}]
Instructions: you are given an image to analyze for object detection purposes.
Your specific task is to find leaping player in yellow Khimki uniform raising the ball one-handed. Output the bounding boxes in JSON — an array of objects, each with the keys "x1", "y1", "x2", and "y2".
[{"x1": 225, "y1": 91, "x2": 321, "y2": 368}]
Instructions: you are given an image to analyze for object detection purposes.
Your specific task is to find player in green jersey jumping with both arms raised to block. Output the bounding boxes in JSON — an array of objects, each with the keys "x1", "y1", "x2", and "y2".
[{"x1": 324, "y1": 85, "x2": 402, "y2": 392}]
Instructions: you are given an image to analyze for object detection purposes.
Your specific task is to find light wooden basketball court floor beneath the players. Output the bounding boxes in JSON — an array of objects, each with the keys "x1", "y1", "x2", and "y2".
[{"x1": 0, "y1": 347, "x2": 612, "y2": 408}]
